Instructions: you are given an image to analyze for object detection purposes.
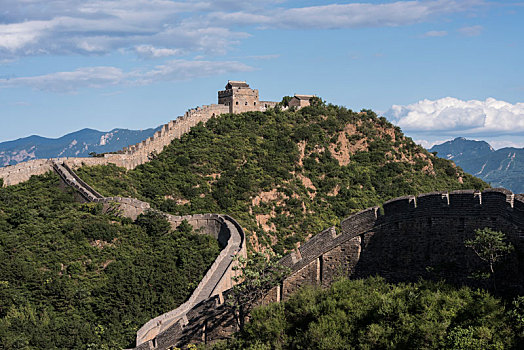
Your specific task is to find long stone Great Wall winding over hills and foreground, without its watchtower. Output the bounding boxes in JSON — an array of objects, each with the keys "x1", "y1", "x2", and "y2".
[{"x1": 0, "y1": 81, "x2": 524, "y2": 350}]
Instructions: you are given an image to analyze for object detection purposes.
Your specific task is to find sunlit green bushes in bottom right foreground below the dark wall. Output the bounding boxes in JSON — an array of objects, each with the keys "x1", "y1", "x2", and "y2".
[{"x1": 213, "y1": 278, "x2": 524, "y2": 350}]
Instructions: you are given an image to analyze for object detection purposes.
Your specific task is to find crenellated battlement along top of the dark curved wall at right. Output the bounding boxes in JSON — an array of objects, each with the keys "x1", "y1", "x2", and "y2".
[{"x1": 281, "y1": 188, "x2": 524, "y2": 278}]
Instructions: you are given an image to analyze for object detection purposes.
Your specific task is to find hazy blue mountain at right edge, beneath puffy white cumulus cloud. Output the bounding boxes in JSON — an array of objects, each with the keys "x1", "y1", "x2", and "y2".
[{"x1": 429, "y1": 137, "x2": 524, "y2": 193}]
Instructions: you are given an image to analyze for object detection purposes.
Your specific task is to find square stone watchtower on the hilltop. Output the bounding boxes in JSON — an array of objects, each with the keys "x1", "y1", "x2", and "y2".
[{"x1": 218, "y1": 80, "x2": 260, "y2": 113}]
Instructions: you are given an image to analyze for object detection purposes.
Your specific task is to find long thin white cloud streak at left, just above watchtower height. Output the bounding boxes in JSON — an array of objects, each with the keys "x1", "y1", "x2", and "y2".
[{"x1": 0, "y1": 60, "x2": 253, "y2": 93}]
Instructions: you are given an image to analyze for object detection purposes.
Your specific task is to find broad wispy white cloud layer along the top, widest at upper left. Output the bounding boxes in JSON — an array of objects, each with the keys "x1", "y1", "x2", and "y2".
[{"x1": 0, "y1": 0, "x2": 484, "y2": 59}]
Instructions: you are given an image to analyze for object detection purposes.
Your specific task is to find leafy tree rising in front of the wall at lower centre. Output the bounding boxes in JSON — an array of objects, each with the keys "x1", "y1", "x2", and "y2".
[{"x1": 226, "y1": 252, "x2": 290, "y2": 330}]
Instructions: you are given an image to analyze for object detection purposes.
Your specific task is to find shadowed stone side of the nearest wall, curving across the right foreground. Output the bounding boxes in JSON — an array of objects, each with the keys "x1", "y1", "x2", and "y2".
[{"x1": 137, "y1": 189, "x2": 524, "y2": 350}]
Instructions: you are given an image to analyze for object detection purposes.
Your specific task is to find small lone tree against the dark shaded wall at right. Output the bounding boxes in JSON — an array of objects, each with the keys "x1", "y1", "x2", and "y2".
[{"x1": 464, "y1": 227, "x2": 514, "y2": 289}]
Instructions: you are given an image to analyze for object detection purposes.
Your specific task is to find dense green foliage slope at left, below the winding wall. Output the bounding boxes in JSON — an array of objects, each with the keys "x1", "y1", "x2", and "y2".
[{"x1": 0, "y1": 174, "x2": 220, "y2": 349}]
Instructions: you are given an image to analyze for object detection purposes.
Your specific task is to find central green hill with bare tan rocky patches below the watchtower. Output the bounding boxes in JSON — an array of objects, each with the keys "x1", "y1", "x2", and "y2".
[{"x1": 75, "y1": 100, "x2": 487, "y2": 254}]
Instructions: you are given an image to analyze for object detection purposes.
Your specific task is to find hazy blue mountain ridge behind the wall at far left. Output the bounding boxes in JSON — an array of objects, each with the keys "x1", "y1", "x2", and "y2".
[{"x1": 0, "y1": 127, "x2": 160, "y2": 167}]
